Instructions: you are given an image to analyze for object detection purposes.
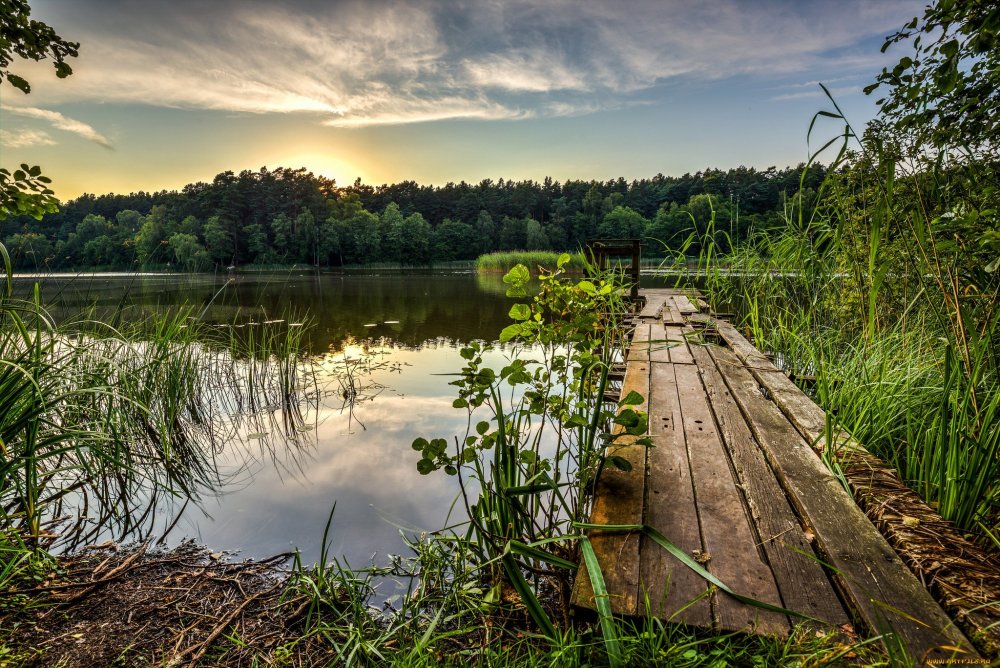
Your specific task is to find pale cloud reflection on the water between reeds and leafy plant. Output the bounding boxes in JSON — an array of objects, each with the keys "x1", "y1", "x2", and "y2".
[{"x1": 172, "y1": 348, "x2": 480, "y2": 566}]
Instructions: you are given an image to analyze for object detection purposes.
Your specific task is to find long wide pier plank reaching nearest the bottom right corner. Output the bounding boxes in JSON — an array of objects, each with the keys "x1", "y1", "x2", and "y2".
[{"x1": 720, "y1": 323, "x2": 975, "y2": 662}]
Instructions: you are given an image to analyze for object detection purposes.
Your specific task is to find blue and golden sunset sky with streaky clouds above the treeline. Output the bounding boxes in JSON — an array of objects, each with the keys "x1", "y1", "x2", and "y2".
[{"x1": 0, "y1": 0, "x2": 924, "y2": 200}]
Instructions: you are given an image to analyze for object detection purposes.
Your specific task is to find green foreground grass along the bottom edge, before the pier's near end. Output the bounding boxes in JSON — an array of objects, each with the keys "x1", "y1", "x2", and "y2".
[{"x1": 268, "y1": 508, "x2": 879, "y2": 668}]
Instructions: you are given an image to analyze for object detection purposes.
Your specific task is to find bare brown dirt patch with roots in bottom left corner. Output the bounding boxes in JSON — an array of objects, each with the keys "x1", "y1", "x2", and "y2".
[{"x1": 0, "y1": 543, "x2": 340, "y2": 666}]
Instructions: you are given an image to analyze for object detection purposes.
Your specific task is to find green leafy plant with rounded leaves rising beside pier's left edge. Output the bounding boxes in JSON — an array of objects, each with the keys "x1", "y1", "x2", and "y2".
[{"x1": 413, "y1": 254, "x2": 649, "y2": 639}]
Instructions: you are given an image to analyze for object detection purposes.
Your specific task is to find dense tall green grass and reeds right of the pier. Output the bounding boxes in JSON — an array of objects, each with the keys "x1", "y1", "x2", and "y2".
[{"x1": 696, "y1": 100, "x2": 1000, "y2": 549}]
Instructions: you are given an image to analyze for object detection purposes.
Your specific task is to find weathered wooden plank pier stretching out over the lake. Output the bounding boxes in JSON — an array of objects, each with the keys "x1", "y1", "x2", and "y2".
[{"x1": 573, "y1": 290, "x2": 977, "y2": 662}]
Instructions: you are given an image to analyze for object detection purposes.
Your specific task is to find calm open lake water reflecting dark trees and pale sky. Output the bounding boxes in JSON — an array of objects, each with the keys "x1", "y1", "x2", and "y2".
[{"x1": 17, "y1": 273, "x2": 676, "y2": 567}]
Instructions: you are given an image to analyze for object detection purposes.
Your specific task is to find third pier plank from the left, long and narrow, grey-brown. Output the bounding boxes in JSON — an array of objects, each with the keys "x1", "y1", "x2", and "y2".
[{"x1": 674, "y1": 365, "x2": 790, "y2": 635}]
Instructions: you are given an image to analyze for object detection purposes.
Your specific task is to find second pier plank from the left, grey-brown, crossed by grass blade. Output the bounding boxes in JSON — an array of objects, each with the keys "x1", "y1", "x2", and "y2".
[{"x1": 640, "y1": 363, "x2": 712, "y2": 626}]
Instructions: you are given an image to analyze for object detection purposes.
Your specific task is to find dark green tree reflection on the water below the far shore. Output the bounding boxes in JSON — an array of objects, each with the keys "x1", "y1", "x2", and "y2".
[{"x1": 19, "y1": 273, "x2": 512, "y2": 354}]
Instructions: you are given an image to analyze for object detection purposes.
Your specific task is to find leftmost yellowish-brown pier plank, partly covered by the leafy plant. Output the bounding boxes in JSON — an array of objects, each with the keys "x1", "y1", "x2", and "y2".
[{"x1": 572, "y1": 358, "x2": 649, "y2": 615}]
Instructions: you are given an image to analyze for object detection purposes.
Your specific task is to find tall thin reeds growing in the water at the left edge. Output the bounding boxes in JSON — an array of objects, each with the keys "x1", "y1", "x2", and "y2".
[{"x1": 0, "y1": 250, "x2": 315, "y2": 546}]
